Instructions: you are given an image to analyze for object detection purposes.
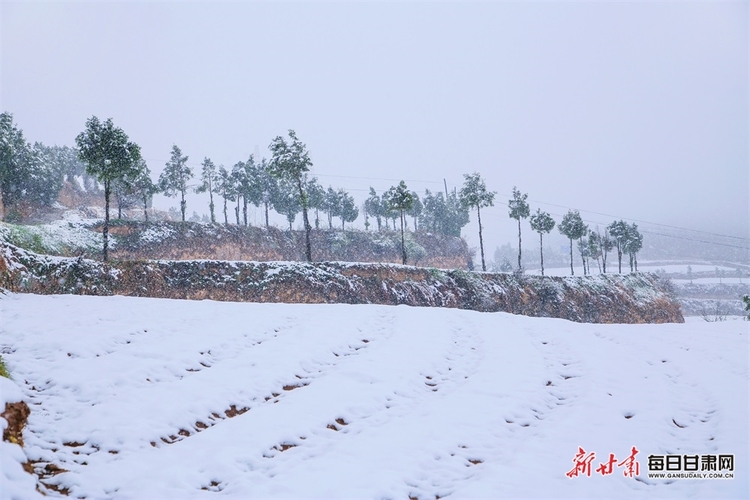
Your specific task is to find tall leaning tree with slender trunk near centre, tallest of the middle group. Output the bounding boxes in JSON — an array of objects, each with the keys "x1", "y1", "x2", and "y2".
[{"x1": 269, "y1": 129, "x2": 312, "y2": 262}]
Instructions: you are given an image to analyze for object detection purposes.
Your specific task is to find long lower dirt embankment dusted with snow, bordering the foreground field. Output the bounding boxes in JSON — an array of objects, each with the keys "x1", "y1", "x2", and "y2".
[{"x1": 0, "y1": 244, "x2": 684, "y2": 323}]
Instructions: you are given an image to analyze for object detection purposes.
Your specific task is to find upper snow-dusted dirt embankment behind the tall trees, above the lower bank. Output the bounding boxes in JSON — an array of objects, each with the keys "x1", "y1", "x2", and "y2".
[{"x1": 100, "y1": 221, "x2": 471, "y2": 269}]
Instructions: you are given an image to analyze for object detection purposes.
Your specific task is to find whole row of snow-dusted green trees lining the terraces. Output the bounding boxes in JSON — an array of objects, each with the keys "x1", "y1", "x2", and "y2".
[{"x1": 0, "y1": 113, "x2": 643, "y2": 274}]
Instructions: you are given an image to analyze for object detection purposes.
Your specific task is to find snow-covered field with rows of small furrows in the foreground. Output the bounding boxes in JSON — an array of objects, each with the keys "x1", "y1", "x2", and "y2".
[{"x1": 0, "y1": 294, "x2": 749, "y2": 499}]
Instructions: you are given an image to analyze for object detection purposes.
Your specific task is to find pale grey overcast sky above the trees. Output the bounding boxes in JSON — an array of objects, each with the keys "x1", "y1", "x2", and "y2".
[{"x1": 0, "y1": 2, "x2": 750, "y2": 262}]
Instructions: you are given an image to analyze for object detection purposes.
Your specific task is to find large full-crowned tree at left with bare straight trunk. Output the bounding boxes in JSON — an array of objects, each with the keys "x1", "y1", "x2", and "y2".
[{"x1": 76, "y1": 116, "x2": 141, "y2": 261}]
